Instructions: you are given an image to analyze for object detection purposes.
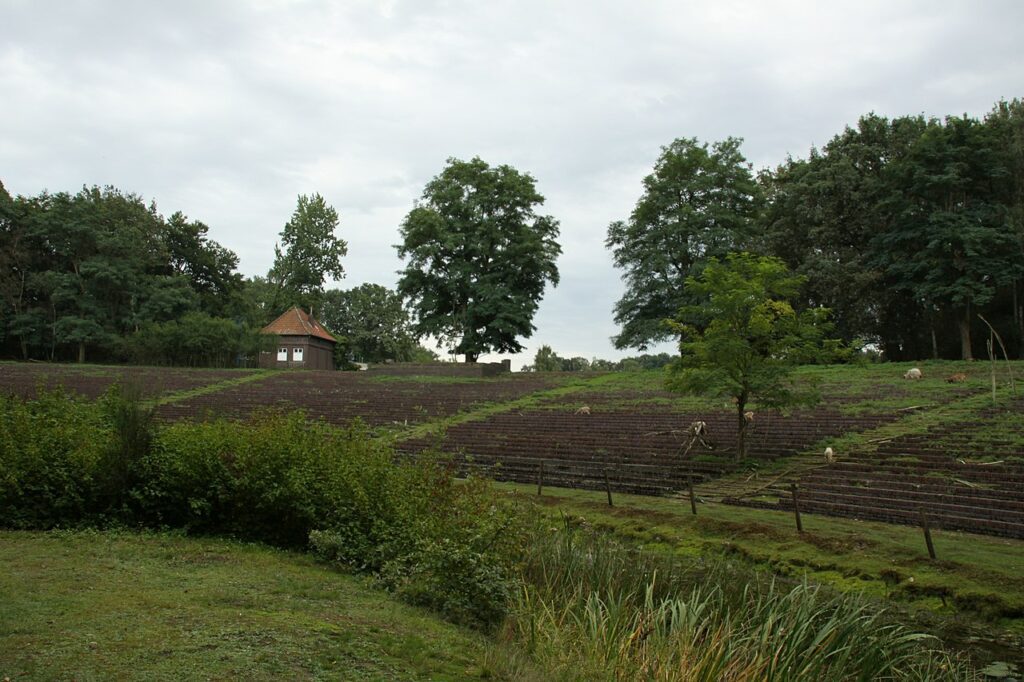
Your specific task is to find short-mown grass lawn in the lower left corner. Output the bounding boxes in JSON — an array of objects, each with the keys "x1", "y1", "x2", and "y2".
[{"x1": 0, "y1": 532, "x2": 485, "y2": 680}]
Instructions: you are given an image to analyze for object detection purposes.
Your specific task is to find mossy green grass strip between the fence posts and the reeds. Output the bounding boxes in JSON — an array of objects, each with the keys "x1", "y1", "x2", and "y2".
[{"x1": 498, "y1": 483, "x2": 1024, "y2": 622}]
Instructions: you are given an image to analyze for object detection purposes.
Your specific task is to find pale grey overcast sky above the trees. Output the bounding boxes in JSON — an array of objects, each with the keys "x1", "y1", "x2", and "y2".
[{"x1": 0, "y1": 0, "x2": 1024, "y2": 367}]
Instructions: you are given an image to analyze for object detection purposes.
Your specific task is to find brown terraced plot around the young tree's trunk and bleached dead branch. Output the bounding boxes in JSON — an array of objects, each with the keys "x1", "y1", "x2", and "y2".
[{"x1": 397, "y1": 410, "x2": 892, "y2": 495}]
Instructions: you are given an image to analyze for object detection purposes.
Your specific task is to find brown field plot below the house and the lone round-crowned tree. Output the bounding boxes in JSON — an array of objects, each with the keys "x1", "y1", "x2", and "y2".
[{"x1": 157, "y1": 372, "x2": 563, "y2": 426}]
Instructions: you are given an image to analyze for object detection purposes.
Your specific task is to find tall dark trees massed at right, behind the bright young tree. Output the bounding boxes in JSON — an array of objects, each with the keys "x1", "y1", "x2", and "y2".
[{"x1": 606, "y1": 99, "x2": 1024, "y2": 359}]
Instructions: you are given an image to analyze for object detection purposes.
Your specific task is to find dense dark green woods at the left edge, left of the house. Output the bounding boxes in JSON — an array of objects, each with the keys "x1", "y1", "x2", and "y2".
[{"x1": 0, "y1": 180, "x2": 243, "y2": 361}]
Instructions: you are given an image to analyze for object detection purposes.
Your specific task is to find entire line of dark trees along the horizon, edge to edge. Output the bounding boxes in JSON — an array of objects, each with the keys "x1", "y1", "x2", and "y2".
[{"x1": 0, "y1": 99, "x2": 1024, "y2": 370}]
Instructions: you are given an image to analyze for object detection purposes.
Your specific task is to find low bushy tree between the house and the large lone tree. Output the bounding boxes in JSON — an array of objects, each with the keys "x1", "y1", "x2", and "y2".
[{"x1": 317, "y1": 284, "x2": 416, "y2": 363}]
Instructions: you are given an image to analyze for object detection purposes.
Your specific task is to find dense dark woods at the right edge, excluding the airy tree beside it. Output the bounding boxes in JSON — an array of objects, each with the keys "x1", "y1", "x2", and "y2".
[{"x1": 759, "y1": 100, "x2": 1024, "y2": 359}]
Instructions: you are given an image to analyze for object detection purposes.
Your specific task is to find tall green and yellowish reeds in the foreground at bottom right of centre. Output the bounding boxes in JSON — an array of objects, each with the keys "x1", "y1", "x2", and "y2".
[{"x1": 506, "y1": 523, "x2": 970, "y2": 680}]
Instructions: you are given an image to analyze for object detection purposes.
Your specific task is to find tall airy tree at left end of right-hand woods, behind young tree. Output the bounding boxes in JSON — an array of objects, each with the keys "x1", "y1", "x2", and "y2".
[{"x1": 605, "y1": 137, "x2": 760, "y2": 349}]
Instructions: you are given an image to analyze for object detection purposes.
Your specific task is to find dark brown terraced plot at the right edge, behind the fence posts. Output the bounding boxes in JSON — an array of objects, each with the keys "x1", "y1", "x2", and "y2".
[{"x1": 734, "y1": 401, "x2": 1024, "y2": 539}]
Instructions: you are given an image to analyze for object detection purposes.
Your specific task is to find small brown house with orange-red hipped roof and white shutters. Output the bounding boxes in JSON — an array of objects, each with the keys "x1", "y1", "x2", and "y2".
[{"x1": 259, "y1": 306, "x2": 338, "y2": 370}]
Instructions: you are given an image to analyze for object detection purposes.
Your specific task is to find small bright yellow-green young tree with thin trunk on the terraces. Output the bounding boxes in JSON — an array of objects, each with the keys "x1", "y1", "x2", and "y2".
[{"x1": 668, "y1": 253, "x2": 842, "y2": 459}]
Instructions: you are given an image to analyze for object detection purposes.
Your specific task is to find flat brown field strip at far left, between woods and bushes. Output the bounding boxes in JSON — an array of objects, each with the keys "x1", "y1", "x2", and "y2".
[{"x1": 0, "y1": 363, "x2": 252, "y2": 398}]
